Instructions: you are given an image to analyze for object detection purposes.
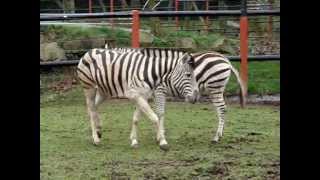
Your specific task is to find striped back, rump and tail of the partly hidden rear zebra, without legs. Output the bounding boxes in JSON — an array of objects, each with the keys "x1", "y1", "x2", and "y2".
[{"x1": 104, "y1": 44, "x2": 245, "y2": 106}]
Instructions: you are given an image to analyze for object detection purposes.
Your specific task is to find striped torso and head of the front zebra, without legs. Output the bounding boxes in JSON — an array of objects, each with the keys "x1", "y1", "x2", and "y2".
[{"x1": 77, "y1": 49, "x2": 195, "y2": 97}]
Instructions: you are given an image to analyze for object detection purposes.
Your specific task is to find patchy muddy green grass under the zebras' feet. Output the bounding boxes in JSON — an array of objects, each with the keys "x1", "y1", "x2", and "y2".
[{"x1": 40, "y1": 87, "x2": 280, "y2": 180}]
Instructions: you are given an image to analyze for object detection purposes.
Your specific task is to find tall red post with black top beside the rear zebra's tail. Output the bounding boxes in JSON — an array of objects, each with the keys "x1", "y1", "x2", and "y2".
[{"x1": 240, "y1": 0, "x2": 248, "y2": 104}]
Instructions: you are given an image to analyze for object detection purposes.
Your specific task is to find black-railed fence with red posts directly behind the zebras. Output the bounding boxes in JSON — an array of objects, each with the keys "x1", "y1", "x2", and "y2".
[{"x1": 40, "y1": 5, "x2": 280, "y2": 101}]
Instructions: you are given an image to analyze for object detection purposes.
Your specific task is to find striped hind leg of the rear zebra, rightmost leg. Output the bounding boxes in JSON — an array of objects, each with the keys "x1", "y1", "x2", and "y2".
[{"x1": 212, "y1": 91, "x2": 226, "y2": 142}]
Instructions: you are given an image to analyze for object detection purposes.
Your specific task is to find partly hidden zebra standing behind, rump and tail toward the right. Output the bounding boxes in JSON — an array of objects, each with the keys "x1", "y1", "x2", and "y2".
[{"x1": 105, "y1": 44, "x2": 245, "y2": 142}]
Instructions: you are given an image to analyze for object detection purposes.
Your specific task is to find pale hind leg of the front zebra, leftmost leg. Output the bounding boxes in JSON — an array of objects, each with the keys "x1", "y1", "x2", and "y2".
[{"x1": 84, "y1": 88, "x2": 100, "y2": 145}]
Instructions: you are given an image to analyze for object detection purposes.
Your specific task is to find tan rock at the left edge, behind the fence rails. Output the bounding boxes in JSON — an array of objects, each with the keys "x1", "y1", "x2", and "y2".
[{"x1": 40, "y1": 42, "x2": 66, "y2": 61}]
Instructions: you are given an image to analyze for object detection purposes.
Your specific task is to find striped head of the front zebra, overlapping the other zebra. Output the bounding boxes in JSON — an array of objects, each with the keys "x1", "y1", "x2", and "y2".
[{"x1": 171, "y1": 53, "x2": 199, "y2": 103}]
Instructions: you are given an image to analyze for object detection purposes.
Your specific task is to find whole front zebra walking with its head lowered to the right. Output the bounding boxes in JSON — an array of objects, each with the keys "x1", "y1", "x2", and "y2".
[{"x1": 77, "y1": 49, "x2": 198, "y2": 149}]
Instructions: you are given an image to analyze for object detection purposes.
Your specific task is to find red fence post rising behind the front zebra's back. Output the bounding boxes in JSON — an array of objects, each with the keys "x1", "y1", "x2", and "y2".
[{"x1": 131, "y1": 10, "x2": 140, "y2": 48}]
